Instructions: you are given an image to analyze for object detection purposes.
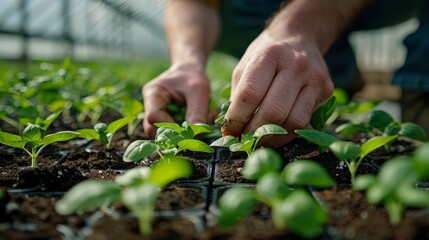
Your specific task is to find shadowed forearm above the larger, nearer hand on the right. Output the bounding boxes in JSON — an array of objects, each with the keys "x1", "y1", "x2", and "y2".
[{"x1": 267, "y1": 0, "x2": 371, "y2": 53}]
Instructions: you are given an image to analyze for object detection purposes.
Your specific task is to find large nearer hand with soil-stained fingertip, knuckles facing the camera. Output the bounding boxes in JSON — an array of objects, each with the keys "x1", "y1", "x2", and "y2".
[{"x1": 222, "y1": 31, "x2": 333, "y2": 147}]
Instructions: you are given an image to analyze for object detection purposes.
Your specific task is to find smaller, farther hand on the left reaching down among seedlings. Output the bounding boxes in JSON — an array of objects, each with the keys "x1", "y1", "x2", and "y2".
[{"x1": 142, "y1": 64, "x2": 210, "y2": 138}]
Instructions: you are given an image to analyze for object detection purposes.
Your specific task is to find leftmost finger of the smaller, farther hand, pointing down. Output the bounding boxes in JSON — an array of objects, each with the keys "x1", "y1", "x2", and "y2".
[{"x1": 143, "y1": 85, "x2": 174, "y2": 138}]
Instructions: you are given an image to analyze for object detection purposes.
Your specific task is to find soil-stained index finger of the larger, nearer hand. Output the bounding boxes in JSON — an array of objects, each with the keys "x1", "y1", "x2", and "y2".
[{"x1": 222, "y1": 54, "x2": 276, "y2": 137}]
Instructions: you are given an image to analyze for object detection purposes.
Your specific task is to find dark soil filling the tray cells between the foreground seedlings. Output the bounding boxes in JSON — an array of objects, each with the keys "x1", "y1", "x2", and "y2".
[{"x1": 0, "y1": 121, "x2": 429, "y2": 240}]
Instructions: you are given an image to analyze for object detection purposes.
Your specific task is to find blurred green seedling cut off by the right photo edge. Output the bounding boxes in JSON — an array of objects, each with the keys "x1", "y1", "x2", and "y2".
[{"x1": 353, "y1": 144, "x2": 429, "y2": 225}]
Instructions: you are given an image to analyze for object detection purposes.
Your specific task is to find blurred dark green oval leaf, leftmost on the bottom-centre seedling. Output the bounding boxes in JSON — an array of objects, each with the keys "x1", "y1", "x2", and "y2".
[{"x1": 218, "y1": 187, "x2": 256, "y2": 229}]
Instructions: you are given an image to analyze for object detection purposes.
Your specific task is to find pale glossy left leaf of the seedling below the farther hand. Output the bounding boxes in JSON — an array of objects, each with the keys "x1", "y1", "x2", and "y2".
[{"x1": 122, "y1": 140, "x2": 159, "y2": 162}]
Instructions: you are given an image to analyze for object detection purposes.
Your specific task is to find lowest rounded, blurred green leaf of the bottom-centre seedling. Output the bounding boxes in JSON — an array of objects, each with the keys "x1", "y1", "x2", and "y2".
[{"x1": 272, "y1": 190, "x2": 328, "y2": 238}]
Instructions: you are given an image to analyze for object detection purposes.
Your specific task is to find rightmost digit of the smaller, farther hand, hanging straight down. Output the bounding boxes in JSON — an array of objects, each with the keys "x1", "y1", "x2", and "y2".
[{"x1": 186, "y1": 81, "x2": 210, "y2": 123}]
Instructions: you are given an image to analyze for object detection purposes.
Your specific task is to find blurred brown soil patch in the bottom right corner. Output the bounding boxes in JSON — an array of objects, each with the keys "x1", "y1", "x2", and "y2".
[{"x1": 315, "y1": 187, "x2": 429, "y2": 240}]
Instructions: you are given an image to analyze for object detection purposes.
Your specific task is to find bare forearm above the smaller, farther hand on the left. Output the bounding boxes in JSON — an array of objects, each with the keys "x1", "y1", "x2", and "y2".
[{"x1": 164, "y1": 0, "x2": 219, "y2": 67}]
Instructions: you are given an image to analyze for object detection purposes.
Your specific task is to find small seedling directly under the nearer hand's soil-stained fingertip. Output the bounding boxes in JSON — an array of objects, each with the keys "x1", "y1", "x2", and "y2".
[{"x1": 210, "y1": 124, "x2": 287, "y2": 156}]
